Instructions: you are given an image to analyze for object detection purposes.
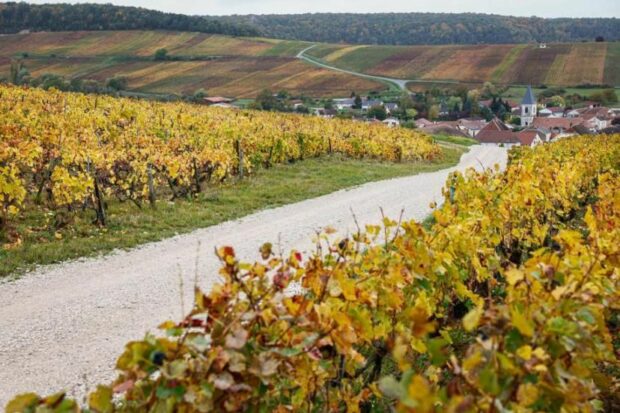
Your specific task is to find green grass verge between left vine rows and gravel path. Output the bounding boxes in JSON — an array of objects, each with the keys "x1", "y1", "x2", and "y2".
[{"x1": 0, "y1": 147, "x2": 466, "y2": 278}]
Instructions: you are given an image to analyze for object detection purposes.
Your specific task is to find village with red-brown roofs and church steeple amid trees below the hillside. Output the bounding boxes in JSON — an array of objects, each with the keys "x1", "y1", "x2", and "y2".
[{"x1": 201, "y1": 86, "x2": 620, "y2": 147}]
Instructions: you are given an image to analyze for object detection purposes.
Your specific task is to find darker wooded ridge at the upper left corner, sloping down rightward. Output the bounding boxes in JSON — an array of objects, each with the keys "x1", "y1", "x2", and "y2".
[{"x1": 0, "y1": 2, "x2": 258, "y2": 36}]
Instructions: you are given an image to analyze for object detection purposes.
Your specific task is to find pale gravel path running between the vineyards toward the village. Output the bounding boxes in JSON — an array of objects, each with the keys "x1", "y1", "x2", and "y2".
[{"x1": 0, "y1": 146, "x2": 506, "y2": 409}]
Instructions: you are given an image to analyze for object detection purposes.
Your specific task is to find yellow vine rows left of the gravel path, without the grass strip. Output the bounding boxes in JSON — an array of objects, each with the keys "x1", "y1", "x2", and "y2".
[{"x1": 0, "y1": 82, "x2": 441, "y2": 248}]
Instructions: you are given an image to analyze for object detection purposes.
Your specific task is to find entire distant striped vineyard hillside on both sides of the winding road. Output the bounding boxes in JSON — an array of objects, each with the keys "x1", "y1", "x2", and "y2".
[{"x1": 0, "y1": 31, "x2": 620, "y2": 98}]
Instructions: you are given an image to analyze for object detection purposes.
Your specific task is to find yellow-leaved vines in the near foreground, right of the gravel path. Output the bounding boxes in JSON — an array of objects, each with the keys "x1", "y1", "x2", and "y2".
[{"x1": 7, "y1": 135, "x2": 620, "y2": 413}]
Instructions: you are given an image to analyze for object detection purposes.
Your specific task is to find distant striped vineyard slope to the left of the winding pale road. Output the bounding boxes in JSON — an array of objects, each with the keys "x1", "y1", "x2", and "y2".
[{"x1": 0, "y1": 31, "x2": 385, "y2": 98}]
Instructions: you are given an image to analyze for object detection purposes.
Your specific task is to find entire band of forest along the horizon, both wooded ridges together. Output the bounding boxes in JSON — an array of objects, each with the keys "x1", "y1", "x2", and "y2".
[{"x1": 0, "y1": 2, "x2": 620, "y2": 45}]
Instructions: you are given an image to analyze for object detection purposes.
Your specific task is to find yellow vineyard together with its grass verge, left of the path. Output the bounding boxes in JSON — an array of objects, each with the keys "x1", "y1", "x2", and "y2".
[{"x1": 0, "y1": 86, "x2": 446, "y2": 276}]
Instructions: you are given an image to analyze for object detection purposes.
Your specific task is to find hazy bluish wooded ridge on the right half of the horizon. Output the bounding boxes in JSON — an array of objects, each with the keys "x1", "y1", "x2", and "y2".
[{"x1": 221, "y1": 13, "x2": 620, "y2": 45}]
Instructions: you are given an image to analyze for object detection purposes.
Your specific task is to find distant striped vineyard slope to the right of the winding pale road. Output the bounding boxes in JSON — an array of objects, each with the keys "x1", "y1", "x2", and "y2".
[{"x1": 309, "y1": 42, "x2": 620, "y2": 86}]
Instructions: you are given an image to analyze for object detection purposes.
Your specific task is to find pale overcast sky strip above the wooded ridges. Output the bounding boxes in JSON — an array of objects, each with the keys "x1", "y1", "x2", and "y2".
[{"x1": 28, "y1": 0, "x2": 620, "y2": 17}]
